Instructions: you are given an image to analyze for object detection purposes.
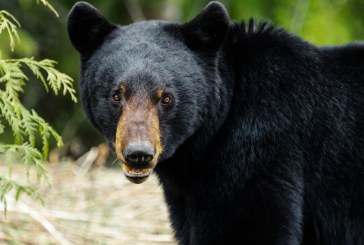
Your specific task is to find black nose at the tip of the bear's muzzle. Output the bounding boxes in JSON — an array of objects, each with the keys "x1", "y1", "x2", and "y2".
[{"x1": 124, "y1": 143, "x2": 154, "y2": 167}]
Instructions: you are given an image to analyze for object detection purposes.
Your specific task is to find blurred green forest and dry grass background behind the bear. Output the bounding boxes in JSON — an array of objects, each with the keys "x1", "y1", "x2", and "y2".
[{"x1": 0, "y1": 0, "x2": 364, "y2": 244}]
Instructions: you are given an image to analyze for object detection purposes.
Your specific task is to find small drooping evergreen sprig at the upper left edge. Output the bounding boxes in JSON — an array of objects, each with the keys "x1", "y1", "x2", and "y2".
[{"x1": 0, "y1": 10, "x2": 20, "y2": 51}]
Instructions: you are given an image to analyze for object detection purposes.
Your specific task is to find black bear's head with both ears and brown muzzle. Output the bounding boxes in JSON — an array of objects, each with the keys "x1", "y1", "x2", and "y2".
[{"x1": 68, "y1": 2, "x2": 229, "y2": 183}]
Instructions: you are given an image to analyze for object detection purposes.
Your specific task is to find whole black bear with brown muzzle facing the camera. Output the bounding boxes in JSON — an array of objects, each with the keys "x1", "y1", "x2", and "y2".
[{"x1": 68, "y1": 2, "x2": 364, "y2": 245}]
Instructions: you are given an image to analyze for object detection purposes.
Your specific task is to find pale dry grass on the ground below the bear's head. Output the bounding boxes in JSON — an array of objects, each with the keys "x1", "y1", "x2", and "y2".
[{"x1": 0, "y1": 164, "x2": 176, "y2": 245}]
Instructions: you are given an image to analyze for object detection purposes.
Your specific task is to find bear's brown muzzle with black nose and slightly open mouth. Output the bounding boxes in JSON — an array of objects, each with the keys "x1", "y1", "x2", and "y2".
[{"x1": 115, "y1": 95, "x2": 163, "y2": 183}]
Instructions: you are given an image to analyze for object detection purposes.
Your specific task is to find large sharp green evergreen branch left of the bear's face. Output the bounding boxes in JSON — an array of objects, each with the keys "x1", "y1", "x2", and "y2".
[{"x1": 0, "y1": 58, "x2": 72, "y2": 155}]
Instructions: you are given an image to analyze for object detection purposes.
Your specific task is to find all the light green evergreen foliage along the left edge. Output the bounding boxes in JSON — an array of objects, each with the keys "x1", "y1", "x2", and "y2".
[{"x1": 0, "y1": 0, "x2": 77, "y2": 210}]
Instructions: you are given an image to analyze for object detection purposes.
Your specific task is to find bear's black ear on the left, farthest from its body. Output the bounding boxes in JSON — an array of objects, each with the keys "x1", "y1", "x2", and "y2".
[{"x1": 67, "y1": 2, "x2": 116, "y2": 57}]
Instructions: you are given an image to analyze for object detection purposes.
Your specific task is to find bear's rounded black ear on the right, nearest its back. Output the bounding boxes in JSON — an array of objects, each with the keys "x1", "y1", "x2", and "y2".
[{"x1": 182, "y1": 1, "x2": 229, "y2": 51}]
